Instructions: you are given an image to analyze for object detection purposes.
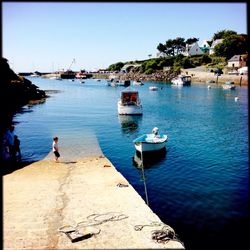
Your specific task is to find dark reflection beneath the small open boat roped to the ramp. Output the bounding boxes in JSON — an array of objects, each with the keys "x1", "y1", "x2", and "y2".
[{"x1": 133, "y1": 147, "x2": 167, "y2": 169}]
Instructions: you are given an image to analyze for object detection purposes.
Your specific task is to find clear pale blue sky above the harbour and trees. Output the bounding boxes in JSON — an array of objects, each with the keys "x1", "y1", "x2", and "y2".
[{"x1": 2, "y1": 2, "x2": 247, "y2": 73}]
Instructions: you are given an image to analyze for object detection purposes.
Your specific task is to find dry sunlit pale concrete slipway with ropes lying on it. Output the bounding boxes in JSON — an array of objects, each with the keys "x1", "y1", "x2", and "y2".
[{"x1": 3, "y1": 155, "x2": 185, "y2": 249}]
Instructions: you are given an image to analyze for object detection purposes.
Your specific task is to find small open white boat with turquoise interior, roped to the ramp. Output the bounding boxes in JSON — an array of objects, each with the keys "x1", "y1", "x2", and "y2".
[{"x1": 133, "y1": 128, "x2": 168, "y2": 153}]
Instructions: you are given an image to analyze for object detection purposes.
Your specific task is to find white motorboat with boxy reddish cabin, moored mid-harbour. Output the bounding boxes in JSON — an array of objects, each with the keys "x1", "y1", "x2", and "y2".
[{"x1": 117, "y1": 87, "x2": 142, "y2": 115}]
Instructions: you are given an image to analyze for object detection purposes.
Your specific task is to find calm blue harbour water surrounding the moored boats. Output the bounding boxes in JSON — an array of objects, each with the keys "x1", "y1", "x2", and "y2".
[{"x1": 14, "y1": 78, "x2": 250, "y2": 249}]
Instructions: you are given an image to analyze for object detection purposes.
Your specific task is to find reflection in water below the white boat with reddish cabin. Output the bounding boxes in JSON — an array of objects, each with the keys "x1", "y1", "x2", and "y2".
[{"x1": 118, "y1": 115, "x2": 142, "y2": 134}]
